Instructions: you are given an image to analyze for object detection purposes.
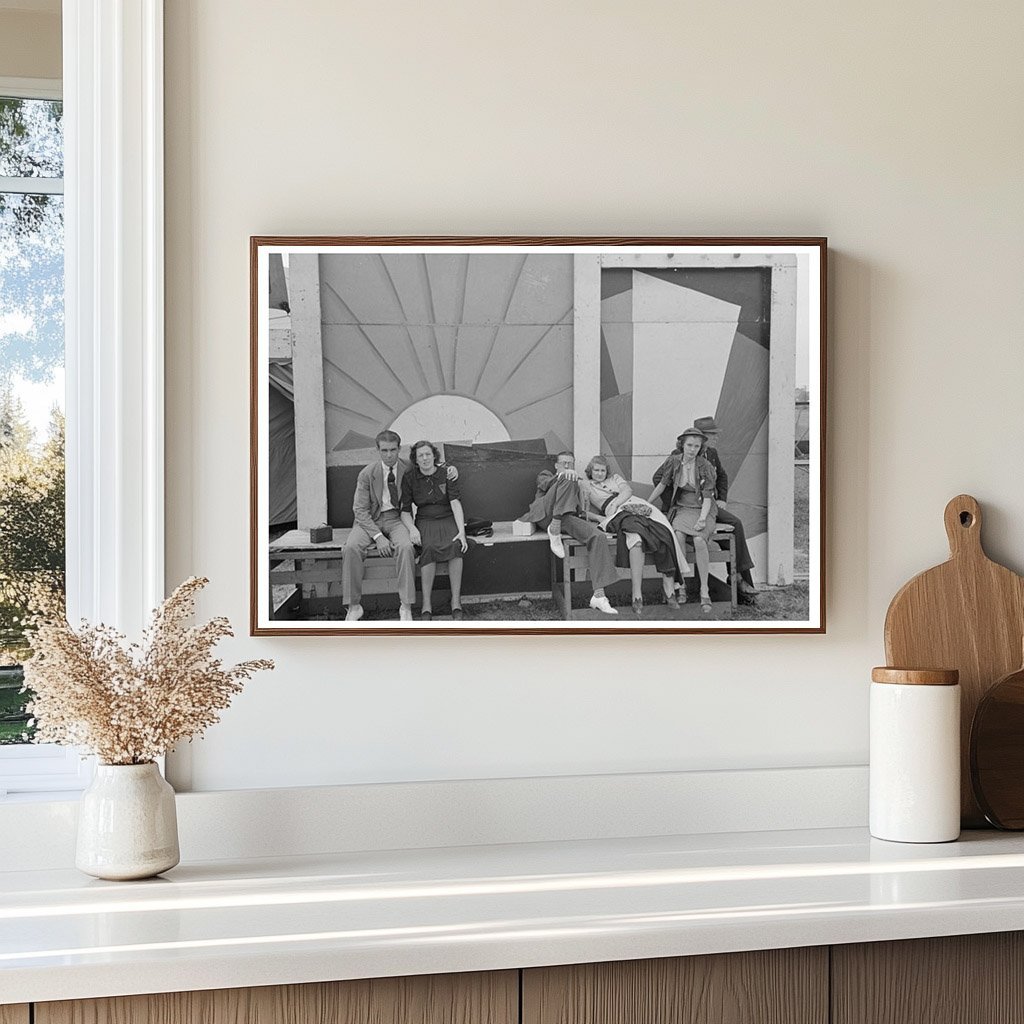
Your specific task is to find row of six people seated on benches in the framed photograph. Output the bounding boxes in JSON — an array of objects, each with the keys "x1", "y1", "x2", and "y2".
[{"x1": 341, "y1": 417, "x2": 753, "y2": 623}]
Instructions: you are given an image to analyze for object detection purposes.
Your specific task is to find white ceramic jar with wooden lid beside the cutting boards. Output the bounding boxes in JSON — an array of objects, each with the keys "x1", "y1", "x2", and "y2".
[{"x1": 869, "y1": 669, "x2": 961, "y2": 843}]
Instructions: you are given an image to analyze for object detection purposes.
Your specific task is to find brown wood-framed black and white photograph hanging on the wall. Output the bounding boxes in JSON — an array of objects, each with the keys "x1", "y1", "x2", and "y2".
[{"x1": 250, "y1": 237, "x2": 826, "y2": 635}]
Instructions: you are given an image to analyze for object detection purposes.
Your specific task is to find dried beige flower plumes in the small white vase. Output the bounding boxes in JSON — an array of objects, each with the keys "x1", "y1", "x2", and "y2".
[{"x1": 25, "y1": 577, "x2": 273, "y2": 765}]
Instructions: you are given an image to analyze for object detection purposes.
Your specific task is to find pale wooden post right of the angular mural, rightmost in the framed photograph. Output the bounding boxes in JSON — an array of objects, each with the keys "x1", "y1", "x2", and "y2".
[{"x1": 766, "y1": 261, "x2": 797, "y2": 584}]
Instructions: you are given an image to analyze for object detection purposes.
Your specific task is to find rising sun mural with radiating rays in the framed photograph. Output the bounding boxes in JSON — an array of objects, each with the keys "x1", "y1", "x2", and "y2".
[{"x1": 321, "y1": 253, "x2": 572, "y2": 456}]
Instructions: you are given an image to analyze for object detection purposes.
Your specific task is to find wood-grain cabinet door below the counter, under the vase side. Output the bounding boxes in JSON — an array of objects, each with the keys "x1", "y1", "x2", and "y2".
[{"x1": 35, "y1": 971, "x2": 519, "y2": 1024}]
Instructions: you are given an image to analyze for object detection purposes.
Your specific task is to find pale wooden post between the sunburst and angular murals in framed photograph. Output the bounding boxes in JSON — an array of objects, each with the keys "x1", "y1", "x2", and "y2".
[{"x1": 572, "y1": 253, "x2": 601, "y2": 460}]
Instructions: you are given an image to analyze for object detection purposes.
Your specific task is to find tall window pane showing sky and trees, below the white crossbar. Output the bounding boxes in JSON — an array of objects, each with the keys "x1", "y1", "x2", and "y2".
[{"x1": 0, "y1": 178, "x2": 65, "y2": 744}]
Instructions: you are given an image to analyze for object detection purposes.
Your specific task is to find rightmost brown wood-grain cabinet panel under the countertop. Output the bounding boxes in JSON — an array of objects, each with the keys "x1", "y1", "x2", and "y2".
[{"x1": 831, "y1": 932, "x2": 1024, "y2": 1024}]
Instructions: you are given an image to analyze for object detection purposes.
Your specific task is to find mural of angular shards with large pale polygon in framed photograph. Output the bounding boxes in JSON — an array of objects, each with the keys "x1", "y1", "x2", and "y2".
[{"x1": 601, "y1": 267, "x2": 771, "y2": 538}]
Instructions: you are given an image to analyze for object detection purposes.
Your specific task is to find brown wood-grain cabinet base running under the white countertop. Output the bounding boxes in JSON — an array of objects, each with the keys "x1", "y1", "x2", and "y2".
[{"x1": 16, "y1": 932, "x2": 1024, "y2": 1024}]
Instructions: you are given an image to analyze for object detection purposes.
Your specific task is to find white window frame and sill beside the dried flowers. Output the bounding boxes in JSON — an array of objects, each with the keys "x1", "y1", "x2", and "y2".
[{"x1": 0, "y1": 0, "x2": 164, "y2": 799}]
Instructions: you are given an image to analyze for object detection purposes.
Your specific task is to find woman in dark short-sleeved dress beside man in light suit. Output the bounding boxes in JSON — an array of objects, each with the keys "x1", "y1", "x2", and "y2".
[{"x1": 401, "y1": 441, "x2": 469, "y2": 620}]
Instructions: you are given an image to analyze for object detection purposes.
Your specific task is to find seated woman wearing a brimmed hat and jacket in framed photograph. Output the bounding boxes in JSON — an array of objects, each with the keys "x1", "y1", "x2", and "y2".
[{"x1": 649, "y1": 427, "x2": 718, "y2": 614}]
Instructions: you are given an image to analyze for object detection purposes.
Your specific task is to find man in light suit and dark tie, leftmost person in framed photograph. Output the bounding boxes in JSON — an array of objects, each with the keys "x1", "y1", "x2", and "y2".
[{"x1": 341, "y1": 430, "x2": 459, "y2": 623}]
